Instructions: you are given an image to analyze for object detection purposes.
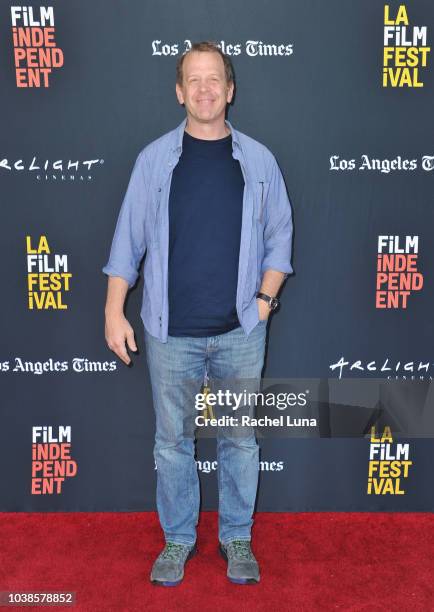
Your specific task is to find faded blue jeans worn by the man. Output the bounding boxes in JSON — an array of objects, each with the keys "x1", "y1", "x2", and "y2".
[{"x1": 145, "y1": 321, "x2": 267, "y2": 545}]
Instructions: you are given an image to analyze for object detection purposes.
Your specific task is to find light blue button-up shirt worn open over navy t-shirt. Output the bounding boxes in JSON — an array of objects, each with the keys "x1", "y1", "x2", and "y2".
[{"x1": 102, "y1": 118, "x2": 293, "y2": 342}]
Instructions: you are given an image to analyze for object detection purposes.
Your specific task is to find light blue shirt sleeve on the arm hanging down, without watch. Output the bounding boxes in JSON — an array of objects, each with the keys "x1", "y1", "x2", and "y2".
[{"x1": 102, "y1": 151, "x2": 149, "y2": 287}]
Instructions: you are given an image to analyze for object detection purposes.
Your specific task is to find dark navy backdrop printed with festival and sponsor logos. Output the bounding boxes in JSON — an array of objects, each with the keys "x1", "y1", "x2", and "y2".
[{"x1": 0, "y1": 0, "x2": 434, "y2": 511}]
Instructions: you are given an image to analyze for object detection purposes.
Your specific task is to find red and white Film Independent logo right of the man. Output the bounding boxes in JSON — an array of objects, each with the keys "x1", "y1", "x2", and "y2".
[{"x1": 375, "y1": 236, "x2": 423, "y2": 308}]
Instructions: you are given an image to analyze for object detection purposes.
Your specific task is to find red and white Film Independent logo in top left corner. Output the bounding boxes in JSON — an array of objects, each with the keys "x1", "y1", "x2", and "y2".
[{"x1": 11, "y1": 6, "x2": 63, "y2": 87}]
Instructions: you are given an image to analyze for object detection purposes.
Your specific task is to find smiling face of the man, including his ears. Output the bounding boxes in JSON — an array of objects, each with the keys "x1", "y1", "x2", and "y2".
[{"x1": 176, "y1": 51, "x2": 234, "y2": 123}]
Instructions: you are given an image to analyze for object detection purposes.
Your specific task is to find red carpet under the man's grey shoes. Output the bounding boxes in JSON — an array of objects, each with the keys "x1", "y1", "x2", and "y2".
[{"x1": 0, "y1": 512, "x2": 434, "y2": 612}]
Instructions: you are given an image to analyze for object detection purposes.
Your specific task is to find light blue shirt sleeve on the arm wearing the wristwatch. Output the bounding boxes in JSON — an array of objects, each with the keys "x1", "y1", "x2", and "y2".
[{"x1": 262, "y1": 157, "x2": 293, "y2": 278}]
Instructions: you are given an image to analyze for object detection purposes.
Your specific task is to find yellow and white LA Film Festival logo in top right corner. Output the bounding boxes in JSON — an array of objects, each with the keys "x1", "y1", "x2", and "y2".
[{"x1": 383, "y1": 4, "x2": 431, "y2": 87}]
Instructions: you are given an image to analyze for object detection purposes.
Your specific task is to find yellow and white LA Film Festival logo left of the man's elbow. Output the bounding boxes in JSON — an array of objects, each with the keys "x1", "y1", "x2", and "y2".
[{"x1": 26, "y1": 236, "x2": 72, "y2": 310}]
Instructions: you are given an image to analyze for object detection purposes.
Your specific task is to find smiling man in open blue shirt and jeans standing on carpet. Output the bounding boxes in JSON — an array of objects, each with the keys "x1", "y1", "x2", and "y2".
[{"x1": 103, "y1": 42, "x2": 292, "y2": 586}]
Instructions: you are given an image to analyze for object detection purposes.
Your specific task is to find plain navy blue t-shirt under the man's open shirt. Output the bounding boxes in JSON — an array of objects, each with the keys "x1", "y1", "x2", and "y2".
[{"x1": 168, "y1": 131, "x2": 244, "y2": 337}]
